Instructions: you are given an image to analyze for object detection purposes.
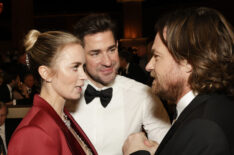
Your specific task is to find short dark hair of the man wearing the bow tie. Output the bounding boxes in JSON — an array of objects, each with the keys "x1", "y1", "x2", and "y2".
[{"x1": 74, "y1": 13, "x2": 117, "y2": 45}]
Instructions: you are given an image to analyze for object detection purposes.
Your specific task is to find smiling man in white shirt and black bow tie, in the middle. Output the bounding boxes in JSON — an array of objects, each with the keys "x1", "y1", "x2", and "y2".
[{"x1": 73, "y1": 14, "x2": 170, "y2": 155}]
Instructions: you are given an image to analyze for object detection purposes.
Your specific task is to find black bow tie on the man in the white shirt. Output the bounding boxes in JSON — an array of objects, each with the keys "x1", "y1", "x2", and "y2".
[{"x1": 84, "y1": 85, "x2": 113, "y2": 108}]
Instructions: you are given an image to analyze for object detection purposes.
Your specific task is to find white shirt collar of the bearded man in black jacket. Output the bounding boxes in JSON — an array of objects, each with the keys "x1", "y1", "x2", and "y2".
[{"x1": 176, "y1": 90, "x2": 197, "y2": 118}]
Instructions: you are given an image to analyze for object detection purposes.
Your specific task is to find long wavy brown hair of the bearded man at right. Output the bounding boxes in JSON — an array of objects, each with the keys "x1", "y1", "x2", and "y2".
[{"x1": 155, "y1": 7, "x2": 234, "y2": 97}]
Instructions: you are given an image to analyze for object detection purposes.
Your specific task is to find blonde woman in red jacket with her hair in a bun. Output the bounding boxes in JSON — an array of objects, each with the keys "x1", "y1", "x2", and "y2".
[{"x1": 8, "y1": 30, "x2": 97, "y2": 155}]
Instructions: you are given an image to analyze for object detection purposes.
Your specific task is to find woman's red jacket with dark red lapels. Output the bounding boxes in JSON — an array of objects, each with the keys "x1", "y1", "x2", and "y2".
[{"x1": 8, "y1": 95, "x2": 97, "y2": 155}]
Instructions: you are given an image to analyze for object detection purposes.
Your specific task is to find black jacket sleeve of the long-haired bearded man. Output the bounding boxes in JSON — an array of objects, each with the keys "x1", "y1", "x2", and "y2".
[{"x1": 163, "y1": 119, "x2": 231, "y2": 155}]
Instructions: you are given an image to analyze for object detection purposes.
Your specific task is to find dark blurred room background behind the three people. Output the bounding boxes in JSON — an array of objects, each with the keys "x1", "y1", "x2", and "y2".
[{"x1": 0, "y1": 0, "x2": 234, "y2": 129}]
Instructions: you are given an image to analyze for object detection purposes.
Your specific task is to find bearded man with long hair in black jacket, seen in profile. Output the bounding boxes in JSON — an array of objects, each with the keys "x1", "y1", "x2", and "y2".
[{"x1": 123, "y1": 7, "x2": 234, "y2": 155}]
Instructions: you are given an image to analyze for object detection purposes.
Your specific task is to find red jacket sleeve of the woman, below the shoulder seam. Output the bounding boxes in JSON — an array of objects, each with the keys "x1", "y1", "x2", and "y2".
[{"x1": 8, "y1": 126, "x2": 61, "y2": 155}]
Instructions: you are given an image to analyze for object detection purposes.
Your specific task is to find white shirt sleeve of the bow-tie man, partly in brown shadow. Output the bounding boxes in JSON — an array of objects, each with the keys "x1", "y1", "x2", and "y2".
[{"x1": 143, "y1": 90, "x2": 171, "y2": 143}]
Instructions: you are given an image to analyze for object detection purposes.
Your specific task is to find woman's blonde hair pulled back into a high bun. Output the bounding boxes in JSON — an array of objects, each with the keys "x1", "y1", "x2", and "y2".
[{"x1": 24, "y1": 30, "x2": 81, "y2": 87}]
